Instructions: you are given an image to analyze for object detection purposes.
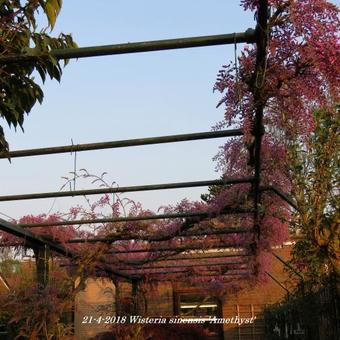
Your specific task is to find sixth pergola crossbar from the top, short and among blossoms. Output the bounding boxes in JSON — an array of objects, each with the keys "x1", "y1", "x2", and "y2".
[{"x1": 108, "y1": 244, "x2": 245, "y2": 254}]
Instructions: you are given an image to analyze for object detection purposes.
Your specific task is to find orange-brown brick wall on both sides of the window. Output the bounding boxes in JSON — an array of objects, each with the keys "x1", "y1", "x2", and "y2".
[{"x1": 135, "y1": 247, "x2": 290, "y2": 340}]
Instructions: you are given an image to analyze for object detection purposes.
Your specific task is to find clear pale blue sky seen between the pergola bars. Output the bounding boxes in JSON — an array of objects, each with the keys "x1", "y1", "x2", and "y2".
[{"x1": 0, "y1": 0, "x2": 255, "y2": 218}]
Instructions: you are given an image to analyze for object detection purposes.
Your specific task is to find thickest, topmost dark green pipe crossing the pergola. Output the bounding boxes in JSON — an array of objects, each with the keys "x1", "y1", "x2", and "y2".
[{"x1": 0, "y1": 28, "x2": 255, "y2": 64}]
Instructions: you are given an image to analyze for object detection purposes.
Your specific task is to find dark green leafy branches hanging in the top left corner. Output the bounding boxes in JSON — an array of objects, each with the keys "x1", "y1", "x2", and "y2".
[{"x1": 0, "y1": 0, "x2": 76, "y2": 152}]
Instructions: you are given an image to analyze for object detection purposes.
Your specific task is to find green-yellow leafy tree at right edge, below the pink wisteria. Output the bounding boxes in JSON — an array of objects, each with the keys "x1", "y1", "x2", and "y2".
[{"x1": 288, "y1": 108, "x2": 340, "y2": 292}]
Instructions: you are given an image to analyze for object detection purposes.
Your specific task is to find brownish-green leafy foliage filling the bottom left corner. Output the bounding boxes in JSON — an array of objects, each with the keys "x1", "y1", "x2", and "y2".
[{"x1": 0, "y1": 262, "x2": 74, "y2": 340}]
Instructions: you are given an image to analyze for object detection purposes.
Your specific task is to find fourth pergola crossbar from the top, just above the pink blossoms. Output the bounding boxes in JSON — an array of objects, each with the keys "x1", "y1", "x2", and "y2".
[{"x1": 18, "y1": 208, "x2": 253, "y2": 228}]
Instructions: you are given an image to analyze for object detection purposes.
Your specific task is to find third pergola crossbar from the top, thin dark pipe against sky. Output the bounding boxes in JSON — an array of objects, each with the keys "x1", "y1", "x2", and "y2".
[{"x1": 0, "y1": 177, "x2": 253, "y2": 202}]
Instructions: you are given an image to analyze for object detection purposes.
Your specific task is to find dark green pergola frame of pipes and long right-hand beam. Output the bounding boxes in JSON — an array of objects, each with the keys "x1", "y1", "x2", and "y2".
[{"x1": 0, "y1": 0, "x2": 296, "y2": 288}]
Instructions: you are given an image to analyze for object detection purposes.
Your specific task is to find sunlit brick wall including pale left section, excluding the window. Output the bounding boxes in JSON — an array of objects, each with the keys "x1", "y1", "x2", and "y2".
[{"x1": 75, "y1": 247, "x2": 290, "y2": 340}]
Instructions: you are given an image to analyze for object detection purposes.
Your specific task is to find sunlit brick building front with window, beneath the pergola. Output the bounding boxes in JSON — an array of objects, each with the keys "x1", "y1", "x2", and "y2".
[{"x1": 75, "y1": 247, "x2": 290, "y2": 340}]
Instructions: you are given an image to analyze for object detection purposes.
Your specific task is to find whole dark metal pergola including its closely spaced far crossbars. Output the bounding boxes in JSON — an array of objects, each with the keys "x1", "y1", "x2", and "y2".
[{"x1": 0, "y1": 0, "x2": 296, "y2": 294}]
